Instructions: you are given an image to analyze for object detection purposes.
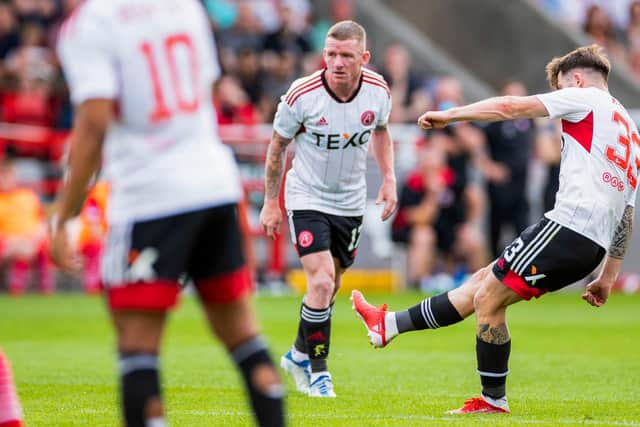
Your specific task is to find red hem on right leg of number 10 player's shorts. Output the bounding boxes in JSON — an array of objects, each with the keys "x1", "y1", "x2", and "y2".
[{"x1": 195, "y1": 266, "x2": 253, "y2": 304}]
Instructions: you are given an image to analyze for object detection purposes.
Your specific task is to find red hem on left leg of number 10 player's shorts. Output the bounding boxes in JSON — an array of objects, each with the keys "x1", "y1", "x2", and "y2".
[{"x1": 107, "y1": 280, "x2": 180, "y2": 311}]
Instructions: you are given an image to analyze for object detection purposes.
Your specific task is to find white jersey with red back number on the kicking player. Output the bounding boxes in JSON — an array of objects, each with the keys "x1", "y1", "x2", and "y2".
[{"x1": 536, "y1": 87, "x2": 640, "y2": 249}]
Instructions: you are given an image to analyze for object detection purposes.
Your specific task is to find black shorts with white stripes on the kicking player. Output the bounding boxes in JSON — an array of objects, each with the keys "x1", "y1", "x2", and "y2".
[{"x1": 493, "y1": 218, "x2": 606, "y2": 300}]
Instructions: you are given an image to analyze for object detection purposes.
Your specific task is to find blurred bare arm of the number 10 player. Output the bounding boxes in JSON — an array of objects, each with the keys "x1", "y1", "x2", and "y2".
[{"x1": 51, "y1": 99, "x2": 113, "y2": 271}]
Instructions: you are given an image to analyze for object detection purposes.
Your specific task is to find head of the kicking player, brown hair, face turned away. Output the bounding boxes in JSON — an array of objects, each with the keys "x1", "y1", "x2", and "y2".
[{"x1": 546, "y1": 44, "x2": 611, "y2": 89}]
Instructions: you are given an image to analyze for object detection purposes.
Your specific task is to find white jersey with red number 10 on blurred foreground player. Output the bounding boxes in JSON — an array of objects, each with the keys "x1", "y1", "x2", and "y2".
[{"x1": 58, "y1": 0, "x2": 241, "y2": 222}]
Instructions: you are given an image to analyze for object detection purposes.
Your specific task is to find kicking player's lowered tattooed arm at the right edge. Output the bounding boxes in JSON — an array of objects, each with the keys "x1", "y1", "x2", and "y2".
[{"x1": 582, "y1": 206, "x2": 633, "y2": 307}]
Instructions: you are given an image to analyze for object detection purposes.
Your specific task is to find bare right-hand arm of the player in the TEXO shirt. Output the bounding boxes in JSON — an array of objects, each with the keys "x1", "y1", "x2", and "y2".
[{"x1": 372, "y1": 125, "x2": 398, "y2": 221}]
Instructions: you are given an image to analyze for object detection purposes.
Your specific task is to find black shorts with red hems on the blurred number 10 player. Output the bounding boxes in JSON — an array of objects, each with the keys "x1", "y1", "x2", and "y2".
[{"x1": 102, "y1": 204, "x2": 250, "y2": 309}]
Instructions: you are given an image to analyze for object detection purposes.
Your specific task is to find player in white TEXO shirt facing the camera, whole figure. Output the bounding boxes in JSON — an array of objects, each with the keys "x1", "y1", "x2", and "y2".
[{"x1": 260, "y1": 21, "x2": 397, "y2": 397}]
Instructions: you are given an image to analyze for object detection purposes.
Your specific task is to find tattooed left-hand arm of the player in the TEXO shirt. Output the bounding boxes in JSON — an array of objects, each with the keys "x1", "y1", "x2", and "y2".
[{"x1": 260, "y1": 131, "x2": 291, "y2": 239}]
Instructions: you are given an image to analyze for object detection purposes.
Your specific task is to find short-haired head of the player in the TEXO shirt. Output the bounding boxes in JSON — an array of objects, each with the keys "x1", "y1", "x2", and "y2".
[{"x1": 323, "y1": 21, "x2": 371, "y2": 84}]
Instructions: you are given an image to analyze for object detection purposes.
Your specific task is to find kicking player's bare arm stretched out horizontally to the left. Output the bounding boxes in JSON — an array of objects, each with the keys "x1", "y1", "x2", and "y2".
[{"x1": 418, "y1": 96, "x2": 549, "y2": 130}]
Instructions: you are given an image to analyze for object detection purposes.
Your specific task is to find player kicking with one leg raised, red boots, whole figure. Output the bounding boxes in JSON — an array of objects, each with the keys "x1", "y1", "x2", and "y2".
[{"x1": 352, "y1": 45, "x2": 640, "y2": 413}]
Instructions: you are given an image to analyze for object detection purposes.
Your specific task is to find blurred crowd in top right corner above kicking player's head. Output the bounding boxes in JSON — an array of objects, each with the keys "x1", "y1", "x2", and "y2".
[{"x1": 536, "y1": 0, "x2": 640, "y2": 81}]
